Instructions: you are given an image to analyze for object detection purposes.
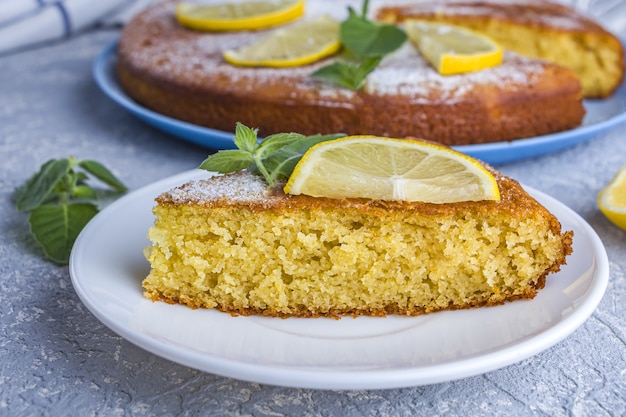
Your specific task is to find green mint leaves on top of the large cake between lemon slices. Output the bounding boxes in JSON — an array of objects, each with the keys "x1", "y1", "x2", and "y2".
[{"x1": 311, "y1": 0, "x2": 407, "y2": 90}]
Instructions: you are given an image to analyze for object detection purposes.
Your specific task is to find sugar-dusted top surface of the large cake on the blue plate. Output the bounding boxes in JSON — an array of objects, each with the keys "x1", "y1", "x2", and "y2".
[{"x1": 119, "y1": 0, "x2": 572, "y2": 106}]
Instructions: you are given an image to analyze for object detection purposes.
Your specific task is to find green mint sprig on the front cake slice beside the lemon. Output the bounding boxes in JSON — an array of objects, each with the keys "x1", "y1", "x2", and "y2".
[{"x1": 200, "y1": 123, "x2": 345, "y2": 185}]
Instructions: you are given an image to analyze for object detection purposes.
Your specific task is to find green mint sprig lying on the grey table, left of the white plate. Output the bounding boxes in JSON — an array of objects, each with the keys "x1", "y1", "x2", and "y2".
[{"x1": 14, "y1": 157, "x2": 127, "y2": 265}]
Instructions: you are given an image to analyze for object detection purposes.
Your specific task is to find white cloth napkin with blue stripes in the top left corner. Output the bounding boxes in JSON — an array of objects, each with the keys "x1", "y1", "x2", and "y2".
[{"x1": 0, "y1": 0, "x2": 154, "y2": 55}]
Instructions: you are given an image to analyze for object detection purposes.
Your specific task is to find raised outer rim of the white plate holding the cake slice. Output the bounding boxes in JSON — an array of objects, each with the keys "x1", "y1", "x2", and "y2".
[{"x1": 69, "y1": 169, "x2": 609, "y2": 390}]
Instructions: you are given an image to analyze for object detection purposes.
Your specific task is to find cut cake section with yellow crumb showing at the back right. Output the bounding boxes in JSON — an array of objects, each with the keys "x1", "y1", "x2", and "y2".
[{"x1": 378, "y1": 0, "x2": 624, "y2": 98}]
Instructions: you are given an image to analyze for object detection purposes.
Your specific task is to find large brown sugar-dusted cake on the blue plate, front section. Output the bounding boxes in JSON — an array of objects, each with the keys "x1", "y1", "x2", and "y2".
[{"x1": 117, "y1": 0, "x2": 585, "y2": 145}]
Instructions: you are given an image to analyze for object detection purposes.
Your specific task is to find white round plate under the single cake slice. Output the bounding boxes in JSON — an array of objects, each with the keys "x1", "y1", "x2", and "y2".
[{"x1": 70, "y1": 170, "x2": 609, "y2": 389}]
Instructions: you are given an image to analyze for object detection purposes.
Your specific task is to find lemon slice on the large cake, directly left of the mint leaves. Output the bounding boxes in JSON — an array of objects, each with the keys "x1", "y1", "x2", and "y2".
[{"x1": 224, "y1": 16, "x2": 341, "y2": 67}]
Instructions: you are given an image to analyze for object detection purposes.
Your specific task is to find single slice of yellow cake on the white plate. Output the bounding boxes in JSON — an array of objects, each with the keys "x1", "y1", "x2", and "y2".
[{"x1": 143, "y1": 168, "x2": 572, "y2": 317}]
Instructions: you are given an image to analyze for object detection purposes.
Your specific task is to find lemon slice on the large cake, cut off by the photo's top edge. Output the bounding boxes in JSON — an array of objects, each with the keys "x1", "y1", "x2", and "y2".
[{"x1": 176, "y1": 0, "x2": 304, "y2": 31}]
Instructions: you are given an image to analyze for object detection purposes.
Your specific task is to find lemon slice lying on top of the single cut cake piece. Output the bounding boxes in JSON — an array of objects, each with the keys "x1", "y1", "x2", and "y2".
[{"x1": 284, "y1": 136, "x2": 500, "y2": 203}]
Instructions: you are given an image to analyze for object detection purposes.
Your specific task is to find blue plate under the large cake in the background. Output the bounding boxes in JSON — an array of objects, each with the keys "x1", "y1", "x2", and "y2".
[{"x1": 92, "y1": 39, "x2": 626, "y2": 165}]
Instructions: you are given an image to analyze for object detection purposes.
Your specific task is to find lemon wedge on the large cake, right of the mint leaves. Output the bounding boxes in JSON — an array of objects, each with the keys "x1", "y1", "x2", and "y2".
[{"x1": 405, "y1": 20, "x2": 502, "y2": 75}]
